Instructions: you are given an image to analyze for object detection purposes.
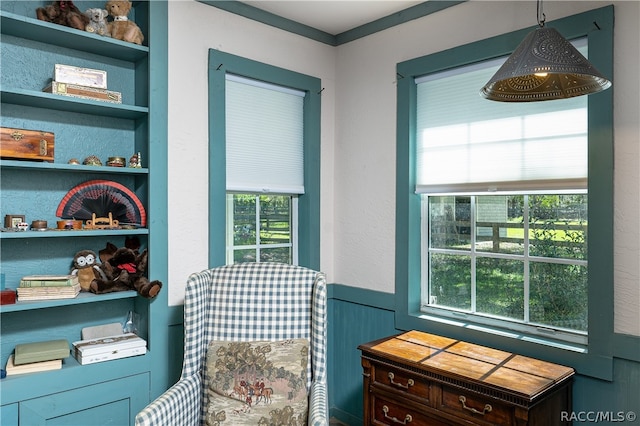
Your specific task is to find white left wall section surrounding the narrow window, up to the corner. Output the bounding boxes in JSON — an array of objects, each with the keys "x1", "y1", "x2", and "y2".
[{"x1": 168, "y1": 1, "x2": 335, "y2": 305}]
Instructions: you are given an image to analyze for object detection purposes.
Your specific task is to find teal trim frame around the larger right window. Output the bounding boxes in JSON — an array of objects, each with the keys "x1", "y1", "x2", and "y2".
[{"x1": 395, "y1": 6, "x2": 615, "y2": 380}]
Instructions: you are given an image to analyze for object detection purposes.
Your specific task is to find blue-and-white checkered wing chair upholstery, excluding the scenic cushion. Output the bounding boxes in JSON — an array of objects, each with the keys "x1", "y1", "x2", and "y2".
[{"x1": 136, "y1": 263, "x2": 329, "y2": 426}]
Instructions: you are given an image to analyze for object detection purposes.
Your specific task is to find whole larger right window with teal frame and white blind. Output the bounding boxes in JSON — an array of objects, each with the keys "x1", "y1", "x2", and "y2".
[{"x1": 396, "y1": 7, "x2": 613, "y2": 378}]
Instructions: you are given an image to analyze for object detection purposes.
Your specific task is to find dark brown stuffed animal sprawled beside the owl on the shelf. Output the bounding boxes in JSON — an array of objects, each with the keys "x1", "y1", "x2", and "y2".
[{"x1": 90, "y1": 247, "x2": 162, "y2": 299}]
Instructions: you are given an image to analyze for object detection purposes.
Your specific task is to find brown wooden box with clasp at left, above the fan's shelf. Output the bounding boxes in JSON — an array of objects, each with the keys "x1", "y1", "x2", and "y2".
[{"x1": 0, "y1": 127, "x2": 55, "y2": 163}]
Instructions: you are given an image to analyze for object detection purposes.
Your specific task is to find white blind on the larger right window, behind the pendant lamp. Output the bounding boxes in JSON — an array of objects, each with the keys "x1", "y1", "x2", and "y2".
[{"x1": 416, "y1": 41, "x2": 588, "y2": 193}]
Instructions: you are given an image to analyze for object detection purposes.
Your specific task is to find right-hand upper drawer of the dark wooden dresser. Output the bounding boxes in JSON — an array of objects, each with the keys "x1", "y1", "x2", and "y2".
[{"x1": 439, "y1": 386, "x2": 515, "y2": 425}]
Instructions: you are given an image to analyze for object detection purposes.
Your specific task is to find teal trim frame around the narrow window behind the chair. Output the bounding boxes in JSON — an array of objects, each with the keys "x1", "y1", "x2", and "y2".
[{"x1": 208, "y1": 49, "x2": 321, "y2": 270}]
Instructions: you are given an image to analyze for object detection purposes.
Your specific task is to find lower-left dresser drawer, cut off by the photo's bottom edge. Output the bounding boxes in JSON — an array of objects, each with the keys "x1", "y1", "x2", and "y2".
[{"x1": 371, "y1": 395, "x2": 451, "y2": 426}]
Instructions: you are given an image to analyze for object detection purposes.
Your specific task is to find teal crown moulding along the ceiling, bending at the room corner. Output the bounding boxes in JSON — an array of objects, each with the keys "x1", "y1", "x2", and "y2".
[{"x1": 198, "y1": 0, "x2": 467, "y2": 46}]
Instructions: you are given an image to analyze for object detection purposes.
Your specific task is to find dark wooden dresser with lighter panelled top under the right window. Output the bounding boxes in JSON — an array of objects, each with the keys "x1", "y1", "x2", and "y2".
[{"x1": 358, "y1": 331, "x2": 574, "y2": 426}]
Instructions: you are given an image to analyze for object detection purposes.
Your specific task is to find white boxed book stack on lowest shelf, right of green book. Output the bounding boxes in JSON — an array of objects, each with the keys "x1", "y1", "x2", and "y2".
[{"x1": 73, "y1": 333, "x2": 147, "y2": 365}]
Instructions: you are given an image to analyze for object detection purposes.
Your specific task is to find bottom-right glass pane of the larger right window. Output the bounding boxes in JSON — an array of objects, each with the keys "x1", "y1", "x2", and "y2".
[{"x1": 530, "y1": 262, "x2": 587, "y2": 331}]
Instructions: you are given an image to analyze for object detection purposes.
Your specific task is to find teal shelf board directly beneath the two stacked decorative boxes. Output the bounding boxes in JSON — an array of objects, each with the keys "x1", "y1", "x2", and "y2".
[{"x1": 0, "y1": 87, "x2": 149, "y2": 120}]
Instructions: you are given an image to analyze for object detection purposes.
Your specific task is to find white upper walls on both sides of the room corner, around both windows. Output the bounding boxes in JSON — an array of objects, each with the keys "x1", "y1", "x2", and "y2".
[{"x1": 169, "y1": 1, "x2": 640, "y2": 335}]
